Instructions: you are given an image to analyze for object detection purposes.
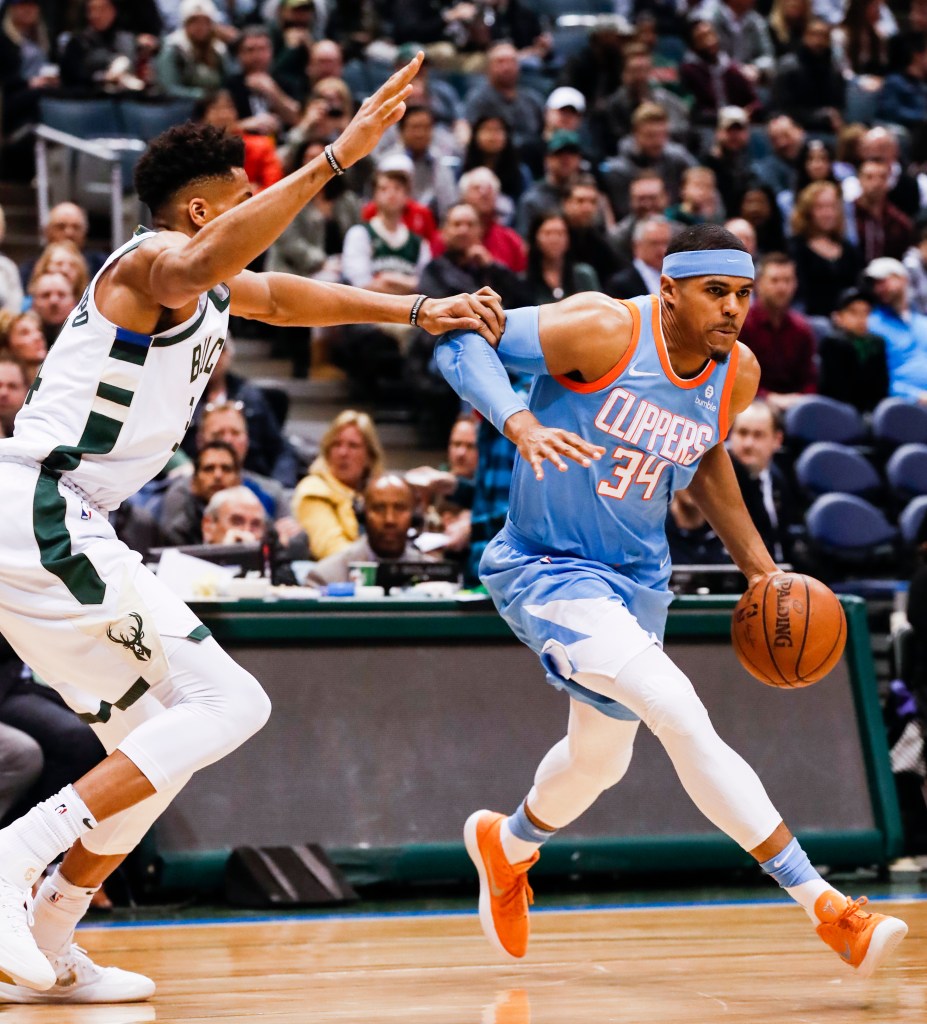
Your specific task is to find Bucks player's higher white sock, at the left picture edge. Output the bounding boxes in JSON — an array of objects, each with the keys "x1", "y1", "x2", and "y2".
[{"x1": 0, "y1": 785, "x2": 96, "y2": 889}]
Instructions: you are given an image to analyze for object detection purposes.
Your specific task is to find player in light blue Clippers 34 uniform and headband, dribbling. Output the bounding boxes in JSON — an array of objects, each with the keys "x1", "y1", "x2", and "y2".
[{"x1": 436, "y1": 224, "x2": 908, "y2": 976}]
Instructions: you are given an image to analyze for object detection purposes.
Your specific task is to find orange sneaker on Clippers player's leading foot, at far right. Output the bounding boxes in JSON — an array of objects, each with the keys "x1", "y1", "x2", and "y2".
[{"x1": 814, "y1": 889, "x2": 908, "y2": 978}]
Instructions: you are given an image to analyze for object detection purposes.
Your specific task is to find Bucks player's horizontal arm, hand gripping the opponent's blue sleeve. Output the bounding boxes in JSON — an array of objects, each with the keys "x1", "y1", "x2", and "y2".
[{"x1": 228, "y1": 270, "x2": 505, "y2": 344}]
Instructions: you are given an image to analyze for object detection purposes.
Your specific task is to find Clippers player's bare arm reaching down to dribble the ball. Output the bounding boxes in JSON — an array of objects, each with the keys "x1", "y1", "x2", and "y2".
[{"x1": 688, "y1": 346, "x2": 777, "y2": 582}]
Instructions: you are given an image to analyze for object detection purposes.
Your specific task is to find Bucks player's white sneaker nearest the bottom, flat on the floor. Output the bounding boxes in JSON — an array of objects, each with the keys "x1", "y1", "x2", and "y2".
[{"x1": 0, "y1": 945, "x2": 155, "y2": 1004}]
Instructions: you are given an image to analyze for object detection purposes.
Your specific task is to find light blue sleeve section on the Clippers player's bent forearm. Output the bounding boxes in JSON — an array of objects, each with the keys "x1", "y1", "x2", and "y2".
[{"x1": 434, "y1": 331, "x2": 528, "y2": 433}]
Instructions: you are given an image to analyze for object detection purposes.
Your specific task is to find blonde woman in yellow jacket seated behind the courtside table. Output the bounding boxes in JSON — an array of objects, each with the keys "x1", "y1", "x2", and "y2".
[{"x1": 293, "y1": 409, "x2": 383, "y2": 561}]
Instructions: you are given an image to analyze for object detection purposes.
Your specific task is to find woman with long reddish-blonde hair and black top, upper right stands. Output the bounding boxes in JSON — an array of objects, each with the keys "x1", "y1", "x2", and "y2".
[{"x1": 790, "y1": 181, "x2": 862, "y2": 316}]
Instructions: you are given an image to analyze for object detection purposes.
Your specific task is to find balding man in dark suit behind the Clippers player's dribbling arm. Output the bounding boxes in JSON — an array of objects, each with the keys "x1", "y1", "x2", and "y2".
[{"x1": 727, "y1": 399, "x2": 795, "y2": 562}]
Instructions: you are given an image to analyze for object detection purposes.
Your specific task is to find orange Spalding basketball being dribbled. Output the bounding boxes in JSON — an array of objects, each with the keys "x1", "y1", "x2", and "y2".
[{"x1": 730, "y1": 572, "x2": 846, "y2": 689}]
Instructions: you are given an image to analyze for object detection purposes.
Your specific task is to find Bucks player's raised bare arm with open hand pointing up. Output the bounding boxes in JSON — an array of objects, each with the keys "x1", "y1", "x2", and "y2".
[{"x1": 149, "y1": 53, "x2": 423, "y2": 309}]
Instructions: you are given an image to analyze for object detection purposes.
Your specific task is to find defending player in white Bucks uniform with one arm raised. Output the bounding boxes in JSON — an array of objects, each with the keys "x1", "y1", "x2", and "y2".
[{"x1": 0, "y1": 54, "x2": 502, "y2": 1002}]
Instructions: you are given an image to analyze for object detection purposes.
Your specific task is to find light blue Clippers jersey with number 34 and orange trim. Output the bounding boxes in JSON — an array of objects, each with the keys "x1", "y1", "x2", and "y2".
[{"x1": 507, "y1": 295, "x2": 738, "y2": 586}]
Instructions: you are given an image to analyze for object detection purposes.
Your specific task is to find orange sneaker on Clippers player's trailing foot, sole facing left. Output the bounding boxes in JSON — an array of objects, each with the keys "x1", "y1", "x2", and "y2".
[{"x1": 464, "y1": 811, "x2": 541, "y2": 958}]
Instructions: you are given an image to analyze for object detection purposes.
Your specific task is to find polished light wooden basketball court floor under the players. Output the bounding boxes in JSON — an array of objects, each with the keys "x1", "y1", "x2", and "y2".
[{"x1": 0, "y1": 897, "x2": 927, "y2": 1024}]
